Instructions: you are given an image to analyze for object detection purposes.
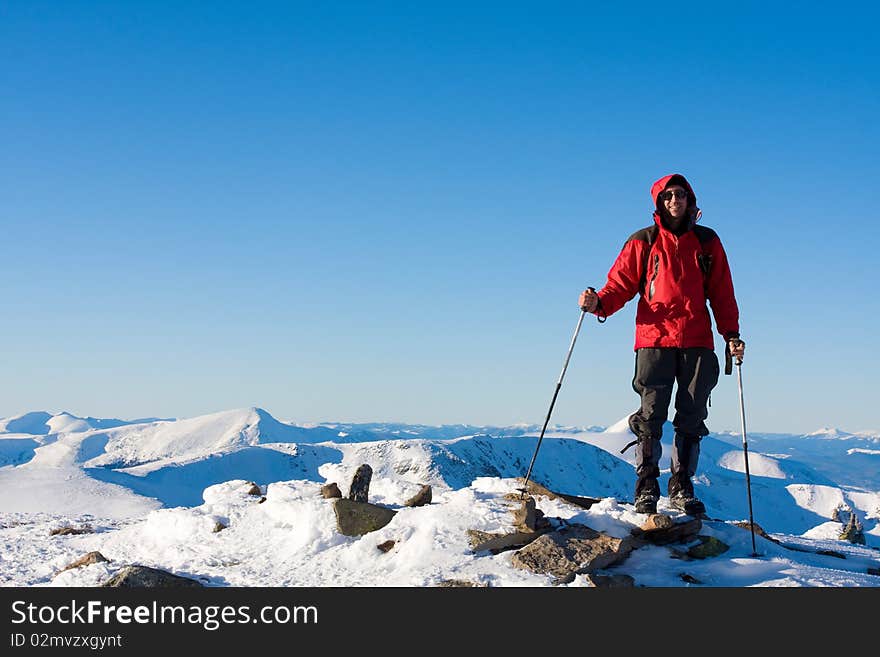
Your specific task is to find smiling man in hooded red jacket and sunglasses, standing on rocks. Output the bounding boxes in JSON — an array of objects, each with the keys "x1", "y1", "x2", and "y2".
[{"x1": 578, "y1": 174, "x2": 745, "y2": 515}]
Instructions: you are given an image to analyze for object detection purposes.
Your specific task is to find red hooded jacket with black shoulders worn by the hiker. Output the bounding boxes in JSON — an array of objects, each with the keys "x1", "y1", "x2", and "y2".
[{"x1": 596, "y1": 174, "x2": 739, "y2": 349}]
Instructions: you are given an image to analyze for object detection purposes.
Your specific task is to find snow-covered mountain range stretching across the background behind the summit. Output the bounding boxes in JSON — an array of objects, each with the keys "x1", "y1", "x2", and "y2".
[{"x1": 0, "y1": 408, "x2": 880, "y2": 538}]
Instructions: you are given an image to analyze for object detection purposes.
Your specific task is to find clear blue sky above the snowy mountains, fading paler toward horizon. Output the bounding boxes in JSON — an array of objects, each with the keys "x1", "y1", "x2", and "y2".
[{"x1": 0, "y1": 2, "x2": 880, "y2": 432}]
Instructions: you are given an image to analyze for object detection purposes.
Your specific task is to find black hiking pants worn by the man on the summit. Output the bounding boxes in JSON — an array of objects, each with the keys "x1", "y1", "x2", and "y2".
[{"x1": 629, "y1": 347, "x2": 720, "y2": 497}]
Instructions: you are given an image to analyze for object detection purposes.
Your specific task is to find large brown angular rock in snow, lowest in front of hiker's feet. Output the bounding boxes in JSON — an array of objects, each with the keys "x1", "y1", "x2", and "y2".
[{"x1": 511, "y1": 524, "x2": 636, "y2": 582}]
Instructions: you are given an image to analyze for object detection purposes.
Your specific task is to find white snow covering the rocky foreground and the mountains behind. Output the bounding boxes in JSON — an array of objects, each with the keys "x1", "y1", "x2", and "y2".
[{"x1": 0, "y1": 408, "x2": 880, "y2": 587}]
